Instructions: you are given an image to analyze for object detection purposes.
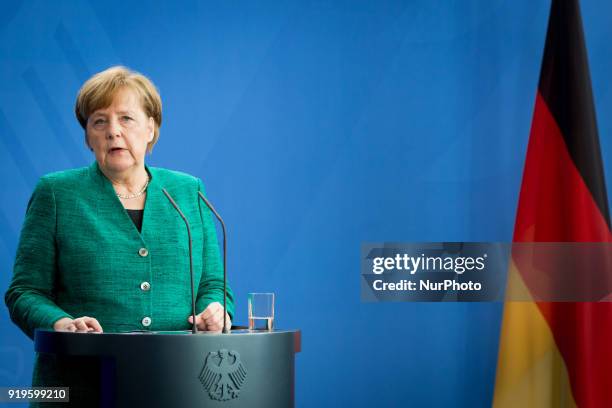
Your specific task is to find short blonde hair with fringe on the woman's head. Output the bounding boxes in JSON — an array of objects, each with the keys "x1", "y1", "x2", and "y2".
[{"x1": 74, "y1": 66, "x2": 162, "y2": 152}]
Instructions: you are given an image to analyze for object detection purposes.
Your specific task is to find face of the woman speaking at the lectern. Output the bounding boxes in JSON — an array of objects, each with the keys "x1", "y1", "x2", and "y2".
[{"x1": 87, "y1": 88, "x2": 155, "y2": 177}]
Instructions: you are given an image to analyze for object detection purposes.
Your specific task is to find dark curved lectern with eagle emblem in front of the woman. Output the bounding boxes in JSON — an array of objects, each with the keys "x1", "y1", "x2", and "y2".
[{"x1": 34, "y1": 330, "x2": 301, "y2": 408}]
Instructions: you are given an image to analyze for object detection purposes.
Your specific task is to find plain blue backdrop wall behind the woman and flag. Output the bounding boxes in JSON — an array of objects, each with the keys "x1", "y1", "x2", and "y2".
[{"x1": 0, "y1": 0, "x2": 612, "y2": 407}]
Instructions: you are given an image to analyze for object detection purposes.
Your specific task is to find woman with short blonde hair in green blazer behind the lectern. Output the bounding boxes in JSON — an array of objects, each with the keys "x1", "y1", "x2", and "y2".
[{"x1": 5, "y1": 66, "x2": 233, "y2": 399}]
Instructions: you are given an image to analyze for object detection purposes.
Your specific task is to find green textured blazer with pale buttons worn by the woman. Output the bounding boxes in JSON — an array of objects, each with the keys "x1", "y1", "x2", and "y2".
[{"x1": 5, "y1": 162, "x2": 234, "y2": 337}]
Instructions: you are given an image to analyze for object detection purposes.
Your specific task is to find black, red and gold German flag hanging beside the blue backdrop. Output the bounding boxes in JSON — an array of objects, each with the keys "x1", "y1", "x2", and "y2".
[{"x1": 493, "y1": 0, "x2": 612, "y2": 408}]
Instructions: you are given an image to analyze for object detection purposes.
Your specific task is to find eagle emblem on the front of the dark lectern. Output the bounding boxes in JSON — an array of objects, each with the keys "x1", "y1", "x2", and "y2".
[{"x1": 199, "y1": 349, "x2": 247, "y2": 401}]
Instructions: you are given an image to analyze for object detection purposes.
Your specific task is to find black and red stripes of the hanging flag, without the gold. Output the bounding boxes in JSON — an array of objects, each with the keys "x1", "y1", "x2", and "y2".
[{"x1": 514, "y1": 0, "x2": 612, "y2": 407}]
